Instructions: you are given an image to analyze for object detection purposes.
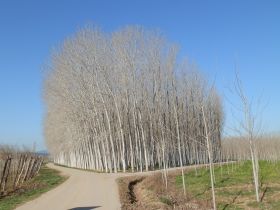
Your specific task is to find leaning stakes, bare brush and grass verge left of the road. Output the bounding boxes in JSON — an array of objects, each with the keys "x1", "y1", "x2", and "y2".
[{"x1": 0, "y1": 145, "x2": 65, "y2": 210}]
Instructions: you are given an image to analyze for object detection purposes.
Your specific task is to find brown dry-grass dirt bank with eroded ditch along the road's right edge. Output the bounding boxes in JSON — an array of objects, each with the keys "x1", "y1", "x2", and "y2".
[{"x1": 118, "y1": 172, "x2": 211, "y2": 210}]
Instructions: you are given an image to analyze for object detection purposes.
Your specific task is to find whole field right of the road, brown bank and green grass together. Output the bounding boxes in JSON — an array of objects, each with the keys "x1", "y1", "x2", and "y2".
[{"x1": 119, "y1": 161, "x2": 280, "y2": 210}]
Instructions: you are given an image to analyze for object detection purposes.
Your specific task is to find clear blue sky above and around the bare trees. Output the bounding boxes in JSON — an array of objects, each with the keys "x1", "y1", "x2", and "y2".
[{"x1": 0, "y1": 0, "x2": 280, "y2": 149}]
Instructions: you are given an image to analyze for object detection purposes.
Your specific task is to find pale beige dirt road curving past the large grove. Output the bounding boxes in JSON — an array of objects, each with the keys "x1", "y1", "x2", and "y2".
[{"x1": 17, "y1": 164, "x2": 121, "y2": 210}]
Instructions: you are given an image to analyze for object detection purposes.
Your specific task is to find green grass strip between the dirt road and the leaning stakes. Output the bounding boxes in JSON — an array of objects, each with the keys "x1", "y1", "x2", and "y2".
[{"x1": 0, "y1": 166, "x2": 67, "y2": 210}]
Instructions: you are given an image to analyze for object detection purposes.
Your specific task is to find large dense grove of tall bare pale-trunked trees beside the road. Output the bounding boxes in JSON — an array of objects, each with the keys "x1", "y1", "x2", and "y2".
[{"x1": 44, "y1": 27, "x2": 223, "y2": 172}]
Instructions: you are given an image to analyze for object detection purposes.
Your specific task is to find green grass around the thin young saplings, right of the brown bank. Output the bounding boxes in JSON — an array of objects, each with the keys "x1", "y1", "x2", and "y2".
[{"x1": 176, "y1": 161, "x2": 280, "y2": 209}]
